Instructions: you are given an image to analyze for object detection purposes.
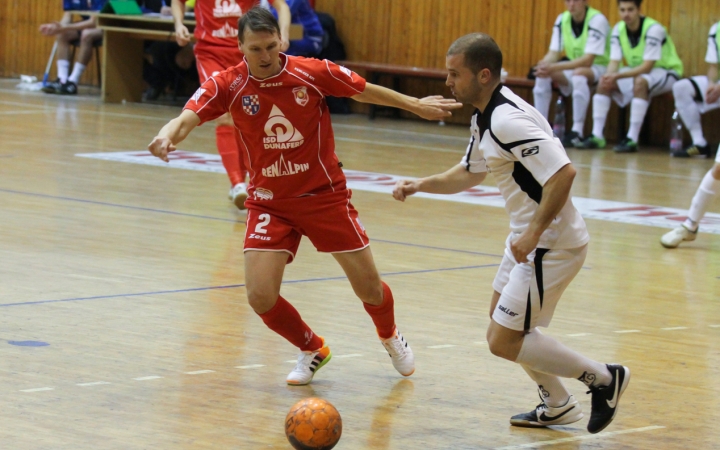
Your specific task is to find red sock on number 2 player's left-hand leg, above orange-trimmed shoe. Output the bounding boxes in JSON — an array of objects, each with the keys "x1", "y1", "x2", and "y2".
[{"x1": 258, "y1": 295, "x2": 323, "y2": 352}]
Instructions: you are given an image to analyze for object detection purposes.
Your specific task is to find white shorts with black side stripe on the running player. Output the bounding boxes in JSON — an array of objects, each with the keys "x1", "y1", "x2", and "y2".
[{"x1": 492, "y1": 238, "x2": 588, "y2": 331}]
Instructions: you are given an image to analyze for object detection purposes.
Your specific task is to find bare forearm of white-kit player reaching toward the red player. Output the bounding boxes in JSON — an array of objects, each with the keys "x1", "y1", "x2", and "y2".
[{"x1": 393, "y1": 164, "x2": 487, "y2": 202}]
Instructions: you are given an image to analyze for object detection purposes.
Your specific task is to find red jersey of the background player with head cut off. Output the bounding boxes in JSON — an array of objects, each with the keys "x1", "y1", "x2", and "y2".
[{"x1": 180, "y1": 0, "x2": 260, "y2": 47}]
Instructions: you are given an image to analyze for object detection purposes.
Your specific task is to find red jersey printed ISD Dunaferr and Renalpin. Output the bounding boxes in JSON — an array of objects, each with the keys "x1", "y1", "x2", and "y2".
[{"x1": 185, "y1": 53, "x2": 365, "y2": 200}]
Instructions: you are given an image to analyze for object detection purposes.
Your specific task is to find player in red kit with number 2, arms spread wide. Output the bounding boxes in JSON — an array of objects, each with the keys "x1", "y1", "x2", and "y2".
[{"x1": 148, "y1": 8, "x2": 460, "y2": 385}]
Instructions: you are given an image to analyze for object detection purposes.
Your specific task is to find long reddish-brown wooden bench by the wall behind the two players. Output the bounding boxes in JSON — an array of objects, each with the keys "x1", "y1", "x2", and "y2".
[{"x1": 337, "y1": 61, "x2": 535, "y2": 120}]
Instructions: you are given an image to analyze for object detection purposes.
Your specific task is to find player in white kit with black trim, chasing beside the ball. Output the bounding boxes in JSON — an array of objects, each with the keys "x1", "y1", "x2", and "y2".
[{"x1": 393, "y1": 33, "x2": 630, "y2": 433}]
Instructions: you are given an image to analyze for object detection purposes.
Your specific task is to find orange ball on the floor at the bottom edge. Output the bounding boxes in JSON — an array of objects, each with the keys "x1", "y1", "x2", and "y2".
[{"x1": 285, "y1": 397, "x2": 342, "y2": 450}]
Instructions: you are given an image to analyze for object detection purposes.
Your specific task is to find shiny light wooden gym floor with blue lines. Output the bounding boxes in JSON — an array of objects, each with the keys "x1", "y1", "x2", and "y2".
[{"x1": 0, "y1": 80, "x2": 720, "y2": 450}]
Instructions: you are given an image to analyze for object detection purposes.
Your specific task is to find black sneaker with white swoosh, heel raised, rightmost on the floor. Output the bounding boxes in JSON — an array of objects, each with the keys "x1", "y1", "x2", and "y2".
[{"x1": 588, "y1": 364, "x2": 630, "y2": 434}]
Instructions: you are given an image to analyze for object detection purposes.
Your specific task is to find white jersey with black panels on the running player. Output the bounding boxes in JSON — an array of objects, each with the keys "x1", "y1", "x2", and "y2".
[{"x1": 462, "y1": 85, "x2": 590, "y2": 249}]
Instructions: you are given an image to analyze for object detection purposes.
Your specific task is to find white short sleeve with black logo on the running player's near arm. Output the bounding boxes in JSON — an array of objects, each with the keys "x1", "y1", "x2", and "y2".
[{"x1": 491, "y1": 106, "x2": 570, "y2": 186}]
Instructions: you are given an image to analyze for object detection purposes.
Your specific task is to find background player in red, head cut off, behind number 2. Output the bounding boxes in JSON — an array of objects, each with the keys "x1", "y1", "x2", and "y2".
[{"x1": 171, "y1": 0, "x2": 290, "y2": 209}]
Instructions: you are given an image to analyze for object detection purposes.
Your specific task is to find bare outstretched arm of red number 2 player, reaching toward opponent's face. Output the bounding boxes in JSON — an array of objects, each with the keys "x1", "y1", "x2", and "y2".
[{"x1": 351, "y1": 83, "x2": 462, "y2": 120}]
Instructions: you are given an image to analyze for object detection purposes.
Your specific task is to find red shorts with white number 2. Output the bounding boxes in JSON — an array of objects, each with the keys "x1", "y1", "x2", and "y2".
[{"x1": 245, "y1": 190, "x2": 370, "y2": 263}]
